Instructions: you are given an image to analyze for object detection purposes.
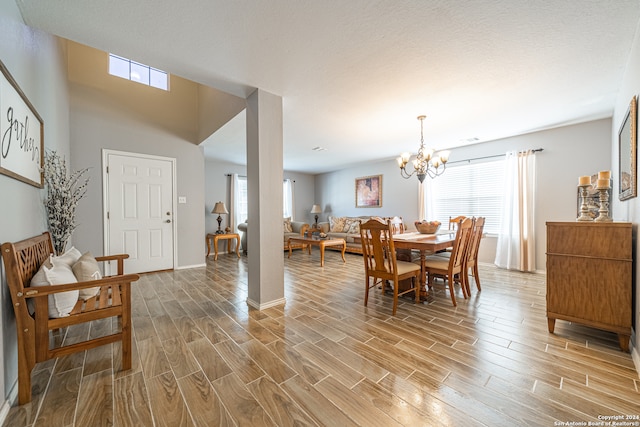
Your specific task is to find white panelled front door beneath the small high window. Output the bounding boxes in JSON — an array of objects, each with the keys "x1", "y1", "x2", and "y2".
[{"x1": 103, "y1": 150, "x2": 175, "y2": 273}]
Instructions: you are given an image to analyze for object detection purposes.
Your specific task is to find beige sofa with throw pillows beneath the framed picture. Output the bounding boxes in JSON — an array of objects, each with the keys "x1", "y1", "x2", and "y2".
[{"x1": 311, "y1": 216, "x2": 405, "y2": 255}]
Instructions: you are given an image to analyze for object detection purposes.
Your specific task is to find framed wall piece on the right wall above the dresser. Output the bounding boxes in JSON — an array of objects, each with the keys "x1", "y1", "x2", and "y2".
[{"x1": 618, "y1": 96, "x2": 638, "y2": 200}]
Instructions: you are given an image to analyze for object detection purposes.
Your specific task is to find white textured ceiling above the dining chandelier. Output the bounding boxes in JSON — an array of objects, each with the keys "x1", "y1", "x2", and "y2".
[{"x1": 16, "y1": 0, "x2": 640, "y2": 173}]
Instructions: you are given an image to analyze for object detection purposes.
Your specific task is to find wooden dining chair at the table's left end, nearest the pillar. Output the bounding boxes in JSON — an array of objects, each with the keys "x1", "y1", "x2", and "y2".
[{"x1": 360, "y1": 219, "x2": 421, "y2": 316}]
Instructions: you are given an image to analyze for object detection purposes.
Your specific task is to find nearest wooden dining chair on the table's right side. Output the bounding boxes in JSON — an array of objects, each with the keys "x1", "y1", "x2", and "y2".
[{"x1": 425, "y1": 218, "x2": 474, "y2": 307}]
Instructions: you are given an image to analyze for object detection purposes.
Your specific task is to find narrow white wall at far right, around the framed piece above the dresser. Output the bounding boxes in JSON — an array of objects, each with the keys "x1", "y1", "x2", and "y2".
[{"x1": 609, "y1": 16, "x2": 640, "y2": 373}]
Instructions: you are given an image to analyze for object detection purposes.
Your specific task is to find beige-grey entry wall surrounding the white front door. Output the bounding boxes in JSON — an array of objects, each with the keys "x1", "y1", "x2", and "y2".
[{"x1": 70, "y1": 84, "x2": 205, "y2": 268}]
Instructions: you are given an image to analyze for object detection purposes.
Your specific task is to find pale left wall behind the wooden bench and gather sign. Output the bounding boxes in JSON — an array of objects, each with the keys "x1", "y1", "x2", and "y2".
[{"x1": 0, "y1": 1, "x2": 69, "y2": 408}]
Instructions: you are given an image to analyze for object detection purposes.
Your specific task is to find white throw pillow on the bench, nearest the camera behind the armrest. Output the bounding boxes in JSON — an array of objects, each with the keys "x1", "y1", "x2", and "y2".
[{"x1": 29, "y1": 262, "x2": 80, "y2": 318}]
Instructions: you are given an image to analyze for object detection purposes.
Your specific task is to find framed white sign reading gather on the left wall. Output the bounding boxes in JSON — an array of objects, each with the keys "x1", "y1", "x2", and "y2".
[{"x1": 0, "y1": 61, "x2": 44, "y2": 188}]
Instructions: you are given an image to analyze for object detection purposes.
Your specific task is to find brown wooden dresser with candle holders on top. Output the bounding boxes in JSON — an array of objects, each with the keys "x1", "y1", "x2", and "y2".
[{"x1": 547, "y1": 222, "x2": 633, "y2": 351}]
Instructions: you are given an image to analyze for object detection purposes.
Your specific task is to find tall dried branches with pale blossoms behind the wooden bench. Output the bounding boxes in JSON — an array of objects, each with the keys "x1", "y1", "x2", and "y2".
[{"x1": 44, "y1": 151, "x2": 89, "y2": 255}]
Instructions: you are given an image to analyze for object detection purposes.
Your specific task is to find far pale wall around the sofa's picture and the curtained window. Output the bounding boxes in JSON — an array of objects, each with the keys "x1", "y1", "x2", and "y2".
[{"x1": 316, "y1": 119, "x2": 608, "y2": 270}]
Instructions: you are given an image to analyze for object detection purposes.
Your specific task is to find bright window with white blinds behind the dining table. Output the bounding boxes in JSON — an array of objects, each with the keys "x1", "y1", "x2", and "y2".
[{"x1": 425, "y1": 159, "x2": 505, "y2": 234}]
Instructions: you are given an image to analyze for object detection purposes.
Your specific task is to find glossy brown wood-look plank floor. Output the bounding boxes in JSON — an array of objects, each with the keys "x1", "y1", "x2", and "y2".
[{"x1": 4, "y1": 251, "x2": 640, "y2": 426}]
